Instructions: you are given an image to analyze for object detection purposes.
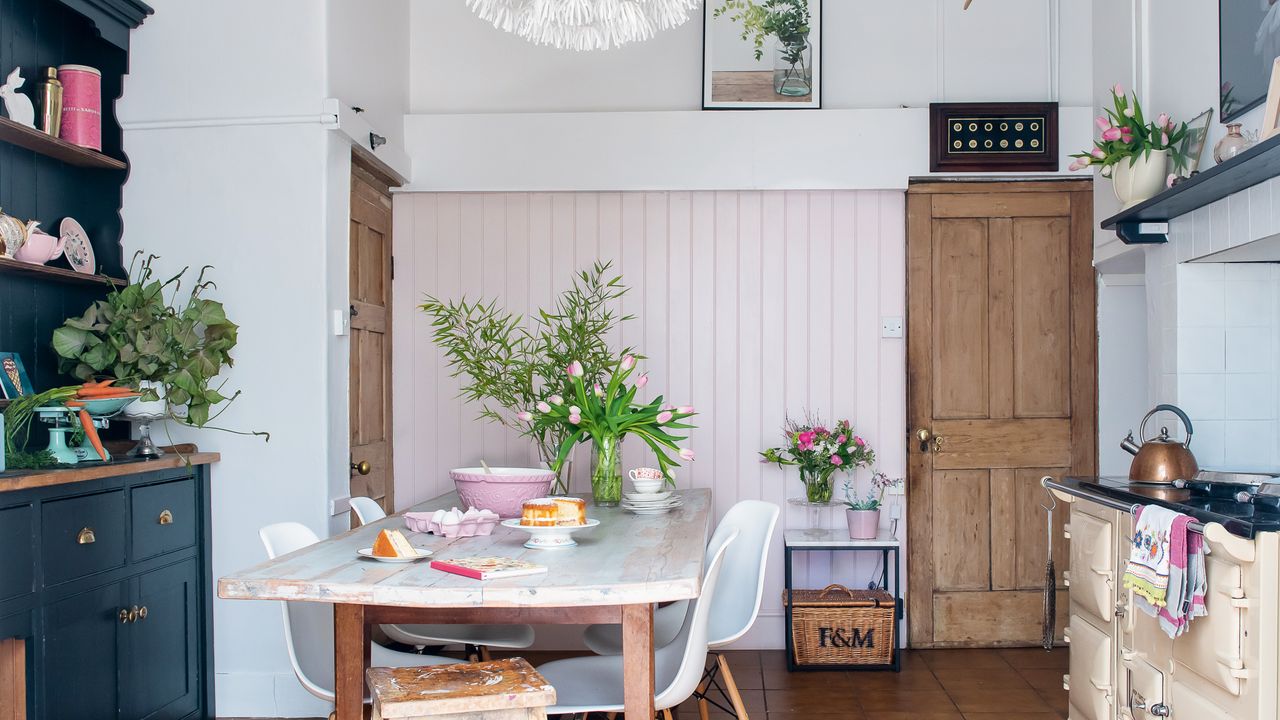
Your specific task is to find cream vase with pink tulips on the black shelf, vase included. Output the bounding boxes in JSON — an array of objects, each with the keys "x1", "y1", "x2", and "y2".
[{"x1": 1070, "y1": 85, "x2": 1187, "y2": 209}]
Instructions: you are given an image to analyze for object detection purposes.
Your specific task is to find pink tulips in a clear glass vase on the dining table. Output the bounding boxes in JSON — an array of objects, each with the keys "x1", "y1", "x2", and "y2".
[{"x1": 518, "y1": 355, "x2": 695, "y2": 506}]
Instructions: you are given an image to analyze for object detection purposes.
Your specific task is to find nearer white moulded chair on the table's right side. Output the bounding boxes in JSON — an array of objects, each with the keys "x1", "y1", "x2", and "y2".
[{"x1": 538, "y1": 529, "x2": 739, "y2": 720}]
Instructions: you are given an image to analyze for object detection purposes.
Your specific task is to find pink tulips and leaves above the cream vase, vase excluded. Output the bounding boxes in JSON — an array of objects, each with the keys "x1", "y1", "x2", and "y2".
[{"x1": 1070, "y1": 85, "x2": 1187, "y2": 177}]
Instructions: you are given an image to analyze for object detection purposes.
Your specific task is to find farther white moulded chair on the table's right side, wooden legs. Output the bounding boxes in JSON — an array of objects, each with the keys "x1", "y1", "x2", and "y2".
[{"x1": 582, "y1": 500, "x2": 778, "y2": 720}]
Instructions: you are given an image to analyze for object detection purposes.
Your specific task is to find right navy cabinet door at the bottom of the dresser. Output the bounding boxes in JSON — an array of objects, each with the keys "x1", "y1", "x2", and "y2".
[{"x1": 120, "y1": 560, "x2": 201, "y2": 720}]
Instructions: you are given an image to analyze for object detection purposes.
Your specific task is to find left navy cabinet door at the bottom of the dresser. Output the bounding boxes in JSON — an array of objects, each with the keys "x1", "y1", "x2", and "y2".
[{"x1": 40, "y1": 583, "x2": 128, "y2": 720}]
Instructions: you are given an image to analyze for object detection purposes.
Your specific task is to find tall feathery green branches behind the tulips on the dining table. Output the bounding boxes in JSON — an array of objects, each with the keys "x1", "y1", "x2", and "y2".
[{"x1": 421, "y1": 263, "x2": 639, "y2": 491}]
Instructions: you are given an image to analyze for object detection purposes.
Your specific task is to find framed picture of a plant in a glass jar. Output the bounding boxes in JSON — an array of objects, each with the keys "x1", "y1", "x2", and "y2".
[{"x1": 703, "y1": 0, "x2": 822, "y2": 110}]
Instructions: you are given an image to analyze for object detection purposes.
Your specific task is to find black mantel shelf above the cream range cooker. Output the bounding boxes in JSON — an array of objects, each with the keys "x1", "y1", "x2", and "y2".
[{"x1": 1102, "y1": 136, "x2": 1280, "y2": 243}]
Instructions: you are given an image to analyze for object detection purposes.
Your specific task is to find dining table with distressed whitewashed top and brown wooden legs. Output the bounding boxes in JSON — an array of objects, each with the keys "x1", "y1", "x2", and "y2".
[{"x1": 218, "y1": 489, "x2": 712, "y2": 720}]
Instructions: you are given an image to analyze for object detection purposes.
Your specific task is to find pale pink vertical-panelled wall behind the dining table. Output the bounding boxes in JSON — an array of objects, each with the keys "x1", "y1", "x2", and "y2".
[{"x1": 393, "y1": 191, "x2": 906, "y2": 647}]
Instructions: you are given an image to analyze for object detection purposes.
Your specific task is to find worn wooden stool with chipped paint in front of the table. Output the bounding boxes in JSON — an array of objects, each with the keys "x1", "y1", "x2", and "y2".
[{"x1": 366, "y1": 657, "x2": 556, "y2": 720}]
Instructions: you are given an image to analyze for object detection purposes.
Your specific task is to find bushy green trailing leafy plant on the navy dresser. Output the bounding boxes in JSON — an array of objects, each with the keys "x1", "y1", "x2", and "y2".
[{"x1": 52, "y1": 251, "x2": 254, "y2": 430}]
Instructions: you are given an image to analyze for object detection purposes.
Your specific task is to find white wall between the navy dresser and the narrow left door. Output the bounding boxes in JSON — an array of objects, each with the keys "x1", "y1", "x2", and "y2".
[{"x1": 119, "y1": 0, "x2": 408, "y2": 717}]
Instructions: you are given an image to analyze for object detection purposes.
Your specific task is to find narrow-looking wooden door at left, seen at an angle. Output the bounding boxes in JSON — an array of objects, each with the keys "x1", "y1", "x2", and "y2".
[{"x1": 351, "y1": 158, "x2": 394, "y2": 512}]
